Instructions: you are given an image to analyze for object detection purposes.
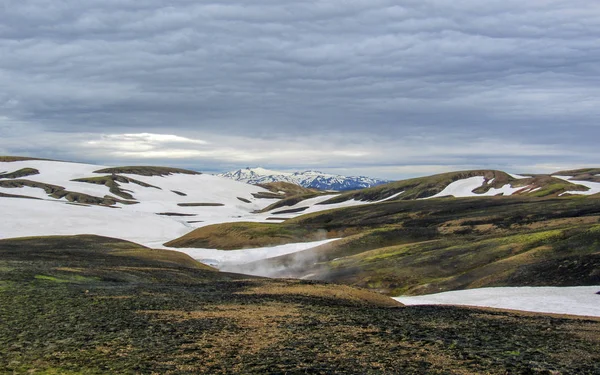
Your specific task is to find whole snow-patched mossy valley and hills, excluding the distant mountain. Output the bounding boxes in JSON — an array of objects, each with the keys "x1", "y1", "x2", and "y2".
[{"x1": 0, "y1": 157, "x2": 600, "y2": 374}]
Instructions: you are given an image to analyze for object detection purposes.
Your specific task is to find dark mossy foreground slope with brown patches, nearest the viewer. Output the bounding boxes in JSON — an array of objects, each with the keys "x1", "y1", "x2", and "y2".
[{"x1": 0, "y1": 236, "x2": 600, "y2": 374}]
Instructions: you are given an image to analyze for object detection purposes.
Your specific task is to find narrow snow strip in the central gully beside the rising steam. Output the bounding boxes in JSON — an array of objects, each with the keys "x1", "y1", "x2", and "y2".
[{"x1": 161, "y1": 238, "x2": 338, "y2": 268}]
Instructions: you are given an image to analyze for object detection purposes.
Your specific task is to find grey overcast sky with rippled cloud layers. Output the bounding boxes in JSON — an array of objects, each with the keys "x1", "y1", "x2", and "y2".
[{"x1": 0, "y1": 0, "x2": 600, "y2": 179}]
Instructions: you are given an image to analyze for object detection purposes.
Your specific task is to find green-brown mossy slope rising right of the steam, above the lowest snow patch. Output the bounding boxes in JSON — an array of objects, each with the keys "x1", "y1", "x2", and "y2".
[{"x1": 238, "y1": 197, "x2": 600, "y2": 295}]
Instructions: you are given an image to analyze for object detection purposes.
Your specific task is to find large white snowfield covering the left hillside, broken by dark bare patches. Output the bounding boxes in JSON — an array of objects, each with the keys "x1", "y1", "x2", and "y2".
[{"x1": 0, "y1": 160, "x2": 272, "y2": 245}]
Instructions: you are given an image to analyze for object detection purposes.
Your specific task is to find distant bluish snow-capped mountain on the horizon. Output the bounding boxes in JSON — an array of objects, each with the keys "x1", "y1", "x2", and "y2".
[{"x1": 219, "y1": 168, "x2": 389, "y2": 191}]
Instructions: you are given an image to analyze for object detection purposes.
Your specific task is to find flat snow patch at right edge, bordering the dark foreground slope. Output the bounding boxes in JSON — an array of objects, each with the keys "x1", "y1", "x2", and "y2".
[{"x1": 394, "y1": 286, "x2": 600, "y2": 317}]
